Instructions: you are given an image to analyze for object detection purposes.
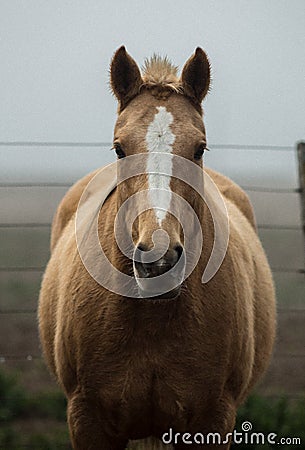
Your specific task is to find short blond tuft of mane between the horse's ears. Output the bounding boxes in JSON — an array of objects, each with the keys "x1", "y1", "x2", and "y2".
[{"x1": 142, "y1": 54, "x2": 182, "y2": 92}]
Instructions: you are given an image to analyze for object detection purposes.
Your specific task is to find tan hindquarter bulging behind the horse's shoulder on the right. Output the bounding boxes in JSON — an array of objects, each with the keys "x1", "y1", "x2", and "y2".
[{"x1": 204, "y1": 167, "x2": 256, "y2": 231}]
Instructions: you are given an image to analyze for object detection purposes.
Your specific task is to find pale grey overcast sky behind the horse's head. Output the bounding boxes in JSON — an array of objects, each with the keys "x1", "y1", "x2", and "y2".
[{"x1": 0, "y1": 0, "x2": 305, "y2": 186}]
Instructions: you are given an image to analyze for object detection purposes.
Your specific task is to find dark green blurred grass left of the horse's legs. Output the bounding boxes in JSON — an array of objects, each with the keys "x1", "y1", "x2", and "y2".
[{"x1": 0, "y1": 371, "x2": 71, "y2": 450}]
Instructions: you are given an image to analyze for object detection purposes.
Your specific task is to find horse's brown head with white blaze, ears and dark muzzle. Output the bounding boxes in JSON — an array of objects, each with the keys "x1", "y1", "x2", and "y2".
[{"x1": 111, "y1": 47, "x2": 210, "y2": 298}]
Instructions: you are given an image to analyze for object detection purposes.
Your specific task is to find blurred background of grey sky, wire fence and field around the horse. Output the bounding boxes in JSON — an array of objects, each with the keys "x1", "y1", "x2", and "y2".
[{"x1": 0, "y1": 0, "x2": 305, "y2": 450}]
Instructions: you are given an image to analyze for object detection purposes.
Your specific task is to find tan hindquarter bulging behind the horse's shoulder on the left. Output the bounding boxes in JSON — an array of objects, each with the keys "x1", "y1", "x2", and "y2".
[{"x1": 51, "y1": 170, "x2": 98, "y2": 252}]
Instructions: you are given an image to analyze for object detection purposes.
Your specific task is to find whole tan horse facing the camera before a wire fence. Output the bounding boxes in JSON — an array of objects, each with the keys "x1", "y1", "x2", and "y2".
[{"x1": 38, "y1": 46, "x2": 276, "y2": 450}]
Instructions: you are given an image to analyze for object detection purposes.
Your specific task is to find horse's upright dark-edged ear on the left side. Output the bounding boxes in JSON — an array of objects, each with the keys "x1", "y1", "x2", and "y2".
[{"x1": 110, "y1": 46, "x2": 143, "y2": 109}]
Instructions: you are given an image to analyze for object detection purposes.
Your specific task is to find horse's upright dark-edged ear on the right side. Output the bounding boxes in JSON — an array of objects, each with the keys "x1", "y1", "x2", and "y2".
[{"x1": 180, "y1": 47, "x2": 211, "y2": 103}]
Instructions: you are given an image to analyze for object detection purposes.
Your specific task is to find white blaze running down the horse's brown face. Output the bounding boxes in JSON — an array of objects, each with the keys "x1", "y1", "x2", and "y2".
[{"x1": 146, "y1": 106, "x2": 176, "y2": 225}]
